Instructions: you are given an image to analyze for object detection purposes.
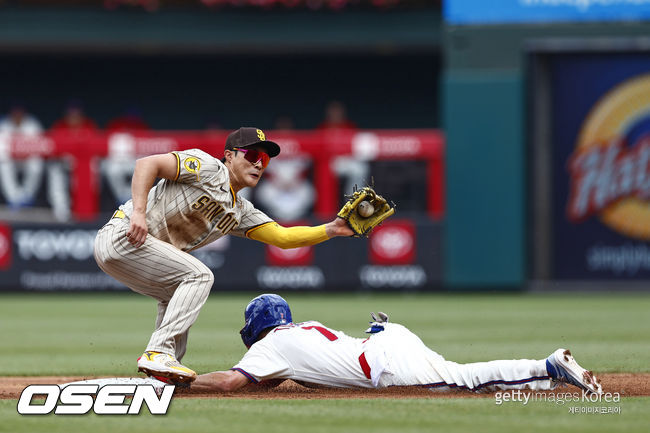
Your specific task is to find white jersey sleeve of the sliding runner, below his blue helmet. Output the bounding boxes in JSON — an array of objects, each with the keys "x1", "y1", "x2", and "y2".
[{"x1": 231, "y1": 338, "x2": 292, "y2": 383}]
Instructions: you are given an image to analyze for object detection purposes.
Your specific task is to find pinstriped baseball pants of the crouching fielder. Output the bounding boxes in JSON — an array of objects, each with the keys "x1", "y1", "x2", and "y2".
[{"x1": 94, "y1": 218, "x2": 214, "y2": 361}]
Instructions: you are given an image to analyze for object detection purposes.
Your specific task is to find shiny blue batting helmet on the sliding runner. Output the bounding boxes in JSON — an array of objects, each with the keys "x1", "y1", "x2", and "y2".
[{"x1": 239, "y1": 293, "x2": 293, "y2": 347}]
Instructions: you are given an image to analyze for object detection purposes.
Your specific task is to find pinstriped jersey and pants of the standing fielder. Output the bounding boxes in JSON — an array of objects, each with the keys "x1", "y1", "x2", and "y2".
[{"x1": 94, "y1": 149, "x2": 272, "y2": 361}]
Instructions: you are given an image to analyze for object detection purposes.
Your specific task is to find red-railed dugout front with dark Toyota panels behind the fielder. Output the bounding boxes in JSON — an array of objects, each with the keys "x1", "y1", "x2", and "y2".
[{"x1": 0, "y1": 130, "x2": 444, "y2": 292}]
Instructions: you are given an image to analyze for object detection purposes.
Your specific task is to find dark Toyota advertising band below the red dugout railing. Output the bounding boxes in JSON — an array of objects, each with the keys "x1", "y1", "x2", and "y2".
[{"x1": 0, "y1": 218, "x2": 442, "y2": 292}]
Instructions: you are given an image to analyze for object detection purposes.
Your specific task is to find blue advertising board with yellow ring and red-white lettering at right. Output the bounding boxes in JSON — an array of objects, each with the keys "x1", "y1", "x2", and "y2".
[{"x1": 551, "y1": 54, "x2": 650, "y2": 280}]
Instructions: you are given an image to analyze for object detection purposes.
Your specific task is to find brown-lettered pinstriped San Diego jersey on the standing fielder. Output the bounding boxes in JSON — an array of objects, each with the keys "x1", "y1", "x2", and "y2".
[{"x1": 120, "y1": 149, "x2": 272, "y2": 251}]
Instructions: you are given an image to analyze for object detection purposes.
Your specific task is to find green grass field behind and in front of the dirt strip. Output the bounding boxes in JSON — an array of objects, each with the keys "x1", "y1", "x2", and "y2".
[{"x1": 0, "y1": 293, "x2": 650, "y2": 433}]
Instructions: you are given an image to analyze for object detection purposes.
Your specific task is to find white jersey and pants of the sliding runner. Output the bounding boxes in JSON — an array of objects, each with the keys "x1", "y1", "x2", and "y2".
[{"x1": 232, "y1": 321, "x2": 553, "y2": 391}]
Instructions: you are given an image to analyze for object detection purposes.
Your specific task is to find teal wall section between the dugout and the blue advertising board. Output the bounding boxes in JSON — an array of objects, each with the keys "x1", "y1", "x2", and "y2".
[{"x1": 441, "y1": 22, "x2": 650, "y2": 289}]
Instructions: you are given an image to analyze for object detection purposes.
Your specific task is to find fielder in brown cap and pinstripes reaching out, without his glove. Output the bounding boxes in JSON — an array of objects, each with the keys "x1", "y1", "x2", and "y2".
[{"x1": 94, "y1": 127, "x2": 354, "y2": 382}]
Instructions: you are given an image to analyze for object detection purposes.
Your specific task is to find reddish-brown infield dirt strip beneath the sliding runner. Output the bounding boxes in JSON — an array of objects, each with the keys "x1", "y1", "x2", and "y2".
[{"x1": 0, "y1": 373, "x2": 650, "y2": 400}]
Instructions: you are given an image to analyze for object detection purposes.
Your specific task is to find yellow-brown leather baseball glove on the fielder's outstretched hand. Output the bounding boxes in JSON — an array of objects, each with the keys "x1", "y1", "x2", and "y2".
[{"x1": 337, "y1": 186, "x2": 395, "y2": 237}]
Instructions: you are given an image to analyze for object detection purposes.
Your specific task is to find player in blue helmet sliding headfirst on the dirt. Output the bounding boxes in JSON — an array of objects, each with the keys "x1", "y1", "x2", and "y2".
[{"x1": 191, "y1": 294, "x2": 602, "y2": 394}]
